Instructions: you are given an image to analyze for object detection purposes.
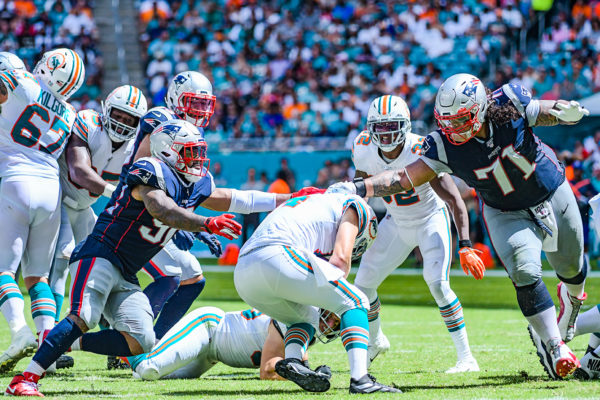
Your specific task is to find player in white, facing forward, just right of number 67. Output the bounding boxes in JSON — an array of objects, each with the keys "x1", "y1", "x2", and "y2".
[{"x1": 50, "y1": 85, "x2": 148, "y2": 322}]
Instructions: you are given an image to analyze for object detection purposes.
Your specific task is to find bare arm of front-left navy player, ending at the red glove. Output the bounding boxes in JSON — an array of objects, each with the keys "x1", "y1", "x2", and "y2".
[{"x1": 131, "y1": 185, "x2": 208, "y2": 232}]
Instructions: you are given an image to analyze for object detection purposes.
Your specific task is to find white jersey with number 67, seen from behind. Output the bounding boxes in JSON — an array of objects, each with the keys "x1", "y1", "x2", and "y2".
[{"x1": 0, "y1": 70, "x2": 76, "y2": 179}]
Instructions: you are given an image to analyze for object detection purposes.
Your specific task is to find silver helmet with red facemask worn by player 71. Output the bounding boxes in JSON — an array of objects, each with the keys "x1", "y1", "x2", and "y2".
[{"x1": 434, "y1": 74, "x2": 488, "y2": 145}]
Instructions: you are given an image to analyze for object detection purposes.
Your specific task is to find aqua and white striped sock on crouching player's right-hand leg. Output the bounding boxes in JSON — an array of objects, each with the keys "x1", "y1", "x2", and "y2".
[{"x1": 340, "y1": 308, "x2": 369, "y2": 379}]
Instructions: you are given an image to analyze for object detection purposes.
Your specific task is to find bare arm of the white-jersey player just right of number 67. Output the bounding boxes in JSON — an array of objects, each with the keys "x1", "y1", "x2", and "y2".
[{"x1": 66, "y1": 135, "x2": 114, "y2": 194}]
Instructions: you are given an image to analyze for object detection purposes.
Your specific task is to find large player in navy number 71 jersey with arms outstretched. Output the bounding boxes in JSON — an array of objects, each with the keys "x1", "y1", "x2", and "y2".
[{"x1": 331, "y1": 74, "x2": 589, "y2": 378}]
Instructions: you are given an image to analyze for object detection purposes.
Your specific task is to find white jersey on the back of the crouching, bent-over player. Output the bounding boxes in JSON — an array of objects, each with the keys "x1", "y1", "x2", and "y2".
[{"x1": 240, "y1": 193, "x2": 369, "y2": 257}]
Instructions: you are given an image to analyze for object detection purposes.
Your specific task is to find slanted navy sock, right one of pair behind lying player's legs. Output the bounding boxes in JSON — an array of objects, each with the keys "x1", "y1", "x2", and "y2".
[{"x1": 154, "y1": 278, "x2": 206, "y2": 340}]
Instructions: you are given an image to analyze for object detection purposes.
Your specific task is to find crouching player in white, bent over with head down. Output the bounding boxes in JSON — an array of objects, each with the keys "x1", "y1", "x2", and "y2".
[{"x1": 234, "y1": 194, "x2": 400, "y2": 393}]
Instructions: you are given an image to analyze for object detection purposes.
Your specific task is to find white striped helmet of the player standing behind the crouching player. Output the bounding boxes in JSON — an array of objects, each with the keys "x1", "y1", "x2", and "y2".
[{"x1": 367, "y1": 95, "x2": 410, "y2": 151}]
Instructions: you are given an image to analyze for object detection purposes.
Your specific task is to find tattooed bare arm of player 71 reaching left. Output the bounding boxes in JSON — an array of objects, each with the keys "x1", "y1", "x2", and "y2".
[{"x1": 364, "y1": 160, "x2": 436, "y2": 197}]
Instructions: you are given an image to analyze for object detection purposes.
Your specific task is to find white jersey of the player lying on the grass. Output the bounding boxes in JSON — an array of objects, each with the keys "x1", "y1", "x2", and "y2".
[{"x1": 212, "y1": 308, "x2": 285, "y2": 368}]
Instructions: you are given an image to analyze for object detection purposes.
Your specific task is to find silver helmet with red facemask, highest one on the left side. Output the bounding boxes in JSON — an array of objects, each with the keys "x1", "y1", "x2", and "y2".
[{"x1": 165, "y1": 71, "x2": 217, "y2": 128}]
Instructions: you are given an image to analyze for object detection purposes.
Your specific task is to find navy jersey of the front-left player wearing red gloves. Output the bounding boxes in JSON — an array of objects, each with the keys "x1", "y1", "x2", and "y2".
[{"x1": 71, "y1": 158, "x2": 214, "y2": 284}]
